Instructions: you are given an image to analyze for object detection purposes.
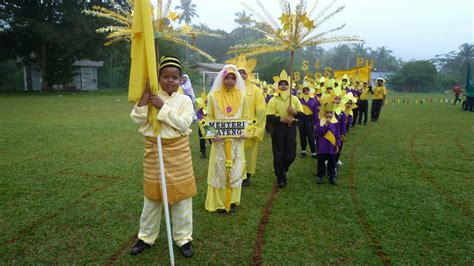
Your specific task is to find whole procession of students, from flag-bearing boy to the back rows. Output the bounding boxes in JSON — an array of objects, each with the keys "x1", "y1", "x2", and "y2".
[{"x1": 130, "y1": 57, "x2": 387, "y2": 257}]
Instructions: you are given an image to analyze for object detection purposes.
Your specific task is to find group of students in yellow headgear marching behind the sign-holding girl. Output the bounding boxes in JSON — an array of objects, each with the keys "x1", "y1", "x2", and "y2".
[{"x1": 264, "y1": 71, "x2": 387, "y2": 187}]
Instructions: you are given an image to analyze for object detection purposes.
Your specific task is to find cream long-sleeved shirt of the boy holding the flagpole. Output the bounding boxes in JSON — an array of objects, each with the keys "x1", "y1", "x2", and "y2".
[{"x1": 130, "y1": 90, "x2": 194, "y2": 139}]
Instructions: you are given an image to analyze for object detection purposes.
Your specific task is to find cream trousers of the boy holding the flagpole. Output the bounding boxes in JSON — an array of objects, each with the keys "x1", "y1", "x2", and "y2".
[{"x1": 138, "y1": 197, "x2": 193, "y2": 247}]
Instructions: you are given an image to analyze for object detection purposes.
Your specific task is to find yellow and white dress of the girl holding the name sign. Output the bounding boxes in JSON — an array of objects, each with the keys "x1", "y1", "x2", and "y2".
[{"x1": 205, "y1": 88, "x2": 246, "y2": 212}]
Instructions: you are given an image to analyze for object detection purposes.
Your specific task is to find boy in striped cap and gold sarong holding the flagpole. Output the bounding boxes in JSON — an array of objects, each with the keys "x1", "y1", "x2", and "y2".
[{"x1": 130, "y1": 57, "x2": 196, "y2": 258}]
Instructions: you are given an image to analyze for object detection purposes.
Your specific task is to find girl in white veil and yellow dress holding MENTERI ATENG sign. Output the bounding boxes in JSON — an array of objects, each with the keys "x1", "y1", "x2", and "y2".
[{"x1": 205, "y1": 65, "x2": 246, "y2": 213}]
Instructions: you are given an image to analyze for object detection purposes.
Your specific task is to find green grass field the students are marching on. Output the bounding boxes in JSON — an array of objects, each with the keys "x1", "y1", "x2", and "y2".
[{"x1": 0, "y1": 92, "x2": 474, "y2": 265}]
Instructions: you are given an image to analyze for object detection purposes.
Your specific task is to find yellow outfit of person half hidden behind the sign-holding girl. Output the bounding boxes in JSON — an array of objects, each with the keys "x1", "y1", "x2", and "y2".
[{"x1": 242, "y1": 81, "x2": 267, "y2": 175}]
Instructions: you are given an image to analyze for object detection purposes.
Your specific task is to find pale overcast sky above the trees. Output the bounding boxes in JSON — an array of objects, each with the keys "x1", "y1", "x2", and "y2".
[{"x1": 155, "y1": 0, "x2": 474, "y2": 60}]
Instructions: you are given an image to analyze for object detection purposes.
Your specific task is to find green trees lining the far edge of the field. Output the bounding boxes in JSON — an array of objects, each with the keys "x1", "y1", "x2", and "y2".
[{"x1": 0, "y1": 0, "x2": 474, "y2": 91}]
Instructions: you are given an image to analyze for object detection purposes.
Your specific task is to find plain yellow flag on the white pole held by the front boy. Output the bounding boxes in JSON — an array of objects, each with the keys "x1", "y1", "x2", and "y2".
[{"x1": 128, "y1": 0, "x2": 160, "y2": 135}]
